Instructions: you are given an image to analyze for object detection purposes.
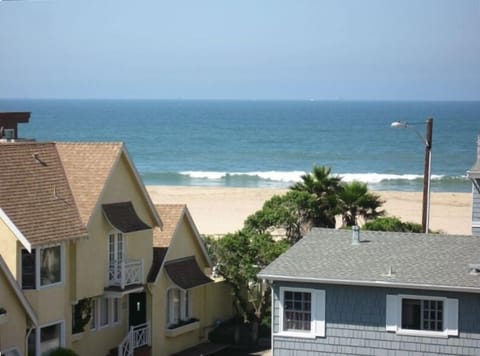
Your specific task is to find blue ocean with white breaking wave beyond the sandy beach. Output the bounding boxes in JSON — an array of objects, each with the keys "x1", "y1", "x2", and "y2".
[{"x1": 0, "y1": 99, "x2": 480, "y2": 192}]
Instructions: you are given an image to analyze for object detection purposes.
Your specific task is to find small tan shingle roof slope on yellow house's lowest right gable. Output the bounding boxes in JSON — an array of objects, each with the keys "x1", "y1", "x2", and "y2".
[{"x1": 153, "y1": 204, "x2": 186, "y2": 247}]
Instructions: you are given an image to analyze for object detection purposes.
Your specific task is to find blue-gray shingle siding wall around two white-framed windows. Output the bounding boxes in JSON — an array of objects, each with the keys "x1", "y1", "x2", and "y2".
[{"x1": 272, "y1": 283, "x2": 480, "y2": 356}]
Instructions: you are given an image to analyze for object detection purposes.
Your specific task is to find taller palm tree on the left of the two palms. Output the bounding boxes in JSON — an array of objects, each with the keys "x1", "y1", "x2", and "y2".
[{"x1": 290, "y1": 166, "x2": 341, "y2": 228}]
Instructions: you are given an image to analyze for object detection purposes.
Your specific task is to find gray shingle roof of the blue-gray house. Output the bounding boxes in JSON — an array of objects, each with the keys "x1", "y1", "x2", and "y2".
[{"x1": 259, "y1": 228, "x2": 480, "y2": 292}]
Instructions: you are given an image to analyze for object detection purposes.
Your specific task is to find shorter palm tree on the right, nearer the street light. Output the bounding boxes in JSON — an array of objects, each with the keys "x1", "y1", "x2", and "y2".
[{"x1": 338, "y1": 181, "x2": 385, "y2": 226}]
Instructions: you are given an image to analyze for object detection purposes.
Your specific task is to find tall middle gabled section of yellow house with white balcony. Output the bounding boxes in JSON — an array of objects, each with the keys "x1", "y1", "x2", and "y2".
[{"x1": 56, "y1": 143, "x2": 162, "y2": 355}]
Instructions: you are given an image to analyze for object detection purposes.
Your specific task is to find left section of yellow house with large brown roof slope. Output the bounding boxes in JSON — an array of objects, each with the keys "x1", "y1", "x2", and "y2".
[{"x1": 0, "y1": 142, "x2": 87, "y2": 355}]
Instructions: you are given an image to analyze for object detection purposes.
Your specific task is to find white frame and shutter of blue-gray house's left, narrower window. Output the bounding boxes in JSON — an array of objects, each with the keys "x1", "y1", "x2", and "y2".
[{"x1": 275, "y1": 287, "x2": 326, "y2": 339}]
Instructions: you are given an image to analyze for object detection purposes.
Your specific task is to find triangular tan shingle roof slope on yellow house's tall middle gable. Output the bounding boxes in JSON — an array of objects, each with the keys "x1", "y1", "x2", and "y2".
[{"x1": 57, "y1": 142, "x2": 123, "y2": 225}]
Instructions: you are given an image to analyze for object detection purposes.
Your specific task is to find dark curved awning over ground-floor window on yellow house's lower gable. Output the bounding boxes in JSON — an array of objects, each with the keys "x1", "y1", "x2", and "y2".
[{"x1": 165, "y1": 256, "x2": 213, "y2": 289}]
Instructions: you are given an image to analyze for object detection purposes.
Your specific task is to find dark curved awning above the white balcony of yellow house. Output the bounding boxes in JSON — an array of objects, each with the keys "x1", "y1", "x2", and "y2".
[{"x1": 102, "y1": 201, "x2": 151, "y2": 233}]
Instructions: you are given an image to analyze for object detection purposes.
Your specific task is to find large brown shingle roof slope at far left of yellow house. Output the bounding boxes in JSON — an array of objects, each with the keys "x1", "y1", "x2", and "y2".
[{"x1": 0, "y1": 142, "x2": 87, "y2": 245}]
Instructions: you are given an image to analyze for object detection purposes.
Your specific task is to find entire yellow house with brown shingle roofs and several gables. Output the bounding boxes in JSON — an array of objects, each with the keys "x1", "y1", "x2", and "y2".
[{"x1": 0, "y1": 113, "x2": 233, "y2": 356}]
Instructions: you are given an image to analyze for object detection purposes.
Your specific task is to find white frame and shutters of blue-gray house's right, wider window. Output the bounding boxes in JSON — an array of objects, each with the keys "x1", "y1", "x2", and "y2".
[{"x1": 386, "y1": 294, "x2": 458, "y2": 338}]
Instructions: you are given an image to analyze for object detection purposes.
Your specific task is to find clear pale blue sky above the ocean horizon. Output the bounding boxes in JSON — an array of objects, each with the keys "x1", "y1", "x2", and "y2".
[{"x1": 0, "y1": 0, "x2": 480, "y2": 100}]
